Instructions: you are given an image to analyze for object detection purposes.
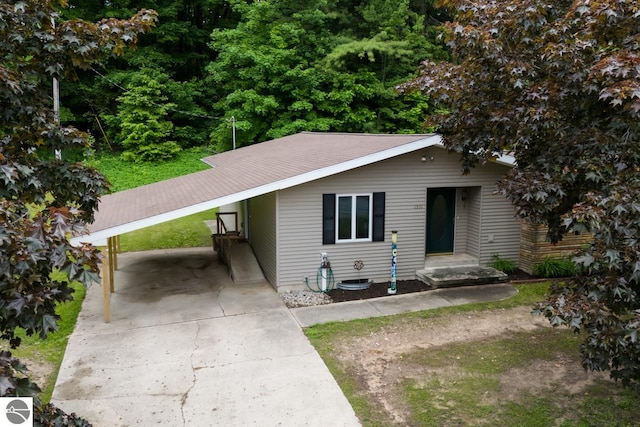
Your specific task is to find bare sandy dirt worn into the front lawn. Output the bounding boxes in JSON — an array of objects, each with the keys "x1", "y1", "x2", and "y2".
[{"x1": 333, "y1": 307, "x2": 604, "y2": 425}]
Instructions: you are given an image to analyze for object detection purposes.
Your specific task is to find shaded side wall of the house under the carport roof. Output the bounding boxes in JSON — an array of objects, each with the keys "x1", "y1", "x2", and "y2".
[{"x1": 249, "y1": 193, "x2": 278, "y2": 287}]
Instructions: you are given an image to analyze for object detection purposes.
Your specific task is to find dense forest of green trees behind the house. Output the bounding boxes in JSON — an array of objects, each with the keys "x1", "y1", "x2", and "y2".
[{"x1": 60, "y1": 0, "x2": 446, "y2": 160}]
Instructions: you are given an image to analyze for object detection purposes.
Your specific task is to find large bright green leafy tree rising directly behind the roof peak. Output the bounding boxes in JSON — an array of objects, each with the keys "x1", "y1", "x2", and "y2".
[{"x1": 208, "y1": 0, "x2": 443, "y2": 149}]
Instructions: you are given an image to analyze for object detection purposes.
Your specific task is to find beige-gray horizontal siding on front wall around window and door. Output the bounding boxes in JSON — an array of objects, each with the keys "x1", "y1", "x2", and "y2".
[{"x1": 278, "y1": 148, "x2": 520, "y2": 291}]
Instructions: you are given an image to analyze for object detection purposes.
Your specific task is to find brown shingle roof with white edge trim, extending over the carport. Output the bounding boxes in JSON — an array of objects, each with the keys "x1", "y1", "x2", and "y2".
[{"x1": 74, "y1": 132, "x2": 440, "y2": 243}]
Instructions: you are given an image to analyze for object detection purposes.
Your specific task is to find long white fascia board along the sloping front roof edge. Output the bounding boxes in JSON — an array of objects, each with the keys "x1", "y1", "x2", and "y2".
[{"x1": 71, "y1": 135, "x2": 442, "y2": 246}]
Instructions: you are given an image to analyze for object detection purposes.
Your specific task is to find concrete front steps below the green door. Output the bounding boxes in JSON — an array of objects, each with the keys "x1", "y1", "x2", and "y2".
[{"x1": 416, "y1": 254, "x2": 508, "y2": 288}]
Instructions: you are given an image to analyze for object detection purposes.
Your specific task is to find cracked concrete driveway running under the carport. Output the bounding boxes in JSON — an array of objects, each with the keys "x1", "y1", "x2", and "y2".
[{"x1": 52, "y1": 248, "x2": 360, "y2": 427}]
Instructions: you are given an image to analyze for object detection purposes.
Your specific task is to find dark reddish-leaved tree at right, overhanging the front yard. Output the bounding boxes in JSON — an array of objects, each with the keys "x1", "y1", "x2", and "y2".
[{"x1": 404, "y1": 0, "x2": 640, "y2": 387}]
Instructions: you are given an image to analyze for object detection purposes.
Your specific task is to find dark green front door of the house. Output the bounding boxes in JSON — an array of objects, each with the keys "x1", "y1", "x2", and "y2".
[{"x1": 427, "y1": 188, "x2": 456, "y2": 254}]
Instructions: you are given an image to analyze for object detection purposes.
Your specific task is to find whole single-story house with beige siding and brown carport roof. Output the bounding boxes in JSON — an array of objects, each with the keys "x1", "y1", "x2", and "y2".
[{"x1": 74, "y1": 132, "x2": 521, "y2": 320}]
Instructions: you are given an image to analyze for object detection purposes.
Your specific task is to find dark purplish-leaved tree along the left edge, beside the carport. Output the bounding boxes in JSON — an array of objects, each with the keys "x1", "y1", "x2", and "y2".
[{"x1": 0, "y1": 0, "x2": 155, "y2": 425}]
